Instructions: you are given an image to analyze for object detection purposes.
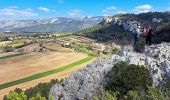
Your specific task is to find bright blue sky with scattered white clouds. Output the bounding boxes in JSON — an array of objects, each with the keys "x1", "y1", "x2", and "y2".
[{"x1": 0, "y1": 0, "x2": 170, "y2": 20}]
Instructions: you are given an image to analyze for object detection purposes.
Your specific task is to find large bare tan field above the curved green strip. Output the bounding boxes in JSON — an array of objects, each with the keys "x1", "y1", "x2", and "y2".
[{"x1": 0, "y1": 52, "x2": 85, "y2": 84}]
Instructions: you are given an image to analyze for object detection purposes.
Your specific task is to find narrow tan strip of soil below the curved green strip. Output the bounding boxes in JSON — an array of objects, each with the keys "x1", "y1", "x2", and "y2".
[{"x1": 0, "y1": 59, "x2": 95, "y2": 100}]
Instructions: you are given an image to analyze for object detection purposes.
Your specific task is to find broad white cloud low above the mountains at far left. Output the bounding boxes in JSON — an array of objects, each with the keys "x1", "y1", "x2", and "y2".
[{"x1": 0, "y1": 7, "x2": 38, "y2": 17}]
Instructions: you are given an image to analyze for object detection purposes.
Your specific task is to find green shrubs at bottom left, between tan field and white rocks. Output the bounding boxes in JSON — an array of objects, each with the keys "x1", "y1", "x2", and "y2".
[{"x1": 3, "y1": 79, "x2": 63, "y2": 100}]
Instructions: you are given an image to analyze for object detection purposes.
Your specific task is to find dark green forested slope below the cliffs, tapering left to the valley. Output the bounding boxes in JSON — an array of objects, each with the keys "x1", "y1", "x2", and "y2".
[{"x1": 75, "y1": 23, "x2": 132, "y2": 44}]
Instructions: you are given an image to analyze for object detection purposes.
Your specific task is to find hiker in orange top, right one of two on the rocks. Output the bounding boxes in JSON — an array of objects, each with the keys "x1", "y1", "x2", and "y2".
[{"x1": 144, "y1": 25, "x2": 152, "y2": 45}]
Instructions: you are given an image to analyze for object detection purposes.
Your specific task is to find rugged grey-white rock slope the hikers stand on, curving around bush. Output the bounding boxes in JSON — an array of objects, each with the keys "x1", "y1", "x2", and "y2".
[{"x1": 50, "y1": 43, "x2": 170, "y2": 100}]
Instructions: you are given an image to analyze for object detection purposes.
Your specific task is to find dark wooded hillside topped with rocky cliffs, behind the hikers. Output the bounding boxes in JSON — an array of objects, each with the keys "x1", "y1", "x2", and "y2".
[{"x1": 76, "y1": 12, "x2": 170, "y2": 44}]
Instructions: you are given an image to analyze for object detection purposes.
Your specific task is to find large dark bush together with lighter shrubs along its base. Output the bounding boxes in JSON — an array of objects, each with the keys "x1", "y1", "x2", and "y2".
[{"x1": 93, "y1": 62, "x2": 170, "y2": 100}]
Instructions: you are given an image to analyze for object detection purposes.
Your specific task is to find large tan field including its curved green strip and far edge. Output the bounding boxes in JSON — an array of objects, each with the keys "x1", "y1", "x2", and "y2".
[{"x1": 0, "y1": 42, "x2": 93, "y2": 99}]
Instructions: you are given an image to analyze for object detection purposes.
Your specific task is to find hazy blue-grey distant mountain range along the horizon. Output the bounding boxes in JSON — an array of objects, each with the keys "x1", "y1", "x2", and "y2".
[{"x1": 0, "y1": 16, "x2": 103, "y2": 32}]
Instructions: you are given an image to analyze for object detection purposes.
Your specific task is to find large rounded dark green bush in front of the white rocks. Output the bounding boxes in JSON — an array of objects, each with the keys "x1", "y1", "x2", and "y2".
[{"x1": 108, "y1": 62, "x2": 150, "y2": 94}]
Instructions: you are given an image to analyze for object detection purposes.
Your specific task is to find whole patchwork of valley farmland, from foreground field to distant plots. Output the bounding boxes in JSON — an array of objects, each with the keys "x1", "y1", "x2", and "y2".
[{"x1": 0, "y1": 34, "x2": 106, "y2": 99}]
